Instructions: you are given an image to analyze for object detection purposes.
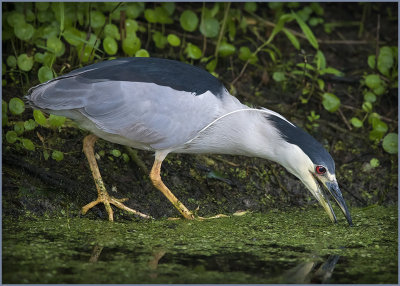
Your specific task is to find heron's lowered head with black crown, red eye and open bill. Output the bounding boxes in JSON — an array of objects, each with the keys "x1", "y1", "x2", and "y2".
[{"x1": 267, "y1": 111, "x2": 353, "y2": 226}]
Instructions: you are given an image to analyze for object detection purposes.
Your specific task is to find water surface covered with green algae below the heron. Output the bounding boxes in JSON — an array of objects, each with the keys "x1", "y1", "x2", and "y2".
[{"x1": 3, "y1": 206, "x2": 398, "y2": 283}]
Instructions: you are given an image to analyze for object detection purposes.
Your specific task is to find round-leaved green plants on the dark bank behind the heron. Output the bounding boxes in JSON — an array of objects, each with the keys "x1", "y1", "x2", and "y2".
[{"x1": 2, "y1": 2, "x2": 398, "y2": 214}]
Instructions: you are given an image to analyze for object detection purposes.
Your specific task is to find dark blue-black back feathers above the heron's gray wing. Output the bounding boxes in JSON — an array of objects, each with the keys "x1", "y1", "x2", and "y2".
[{"x1": 62, "y1": 57, "x2": 225, "y2": 98}]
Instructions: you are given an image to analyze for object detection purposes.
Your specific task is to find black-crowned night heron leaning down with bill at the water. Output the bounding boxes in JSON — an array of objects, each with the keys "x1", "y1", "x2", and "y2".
[{"x1": 26, "y1": 58, "x2": 352, "y2": 225}]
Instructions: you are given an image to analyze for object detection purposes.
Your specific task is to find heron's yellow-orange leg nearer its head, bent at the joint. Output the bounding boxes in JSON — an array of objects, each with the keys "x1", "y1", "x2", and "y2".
[{"x1": 150, "y1": 158, "x2": 194, "y2": 219}]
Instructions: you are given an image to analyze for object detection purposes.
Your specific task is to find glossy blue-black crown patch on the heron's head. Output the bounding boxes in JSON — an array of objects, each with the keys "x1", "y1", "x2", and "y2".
[{"x1": 267, "y1": 115, "x2": 335, "y2": 174}]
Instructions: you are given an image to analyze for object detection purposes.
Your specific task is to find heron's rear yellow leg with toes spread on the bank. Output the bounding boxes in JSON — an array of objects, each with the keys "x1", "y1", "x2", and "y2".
[{"x1": 82, "y1": 134, "x2": 151, "y2": 221}]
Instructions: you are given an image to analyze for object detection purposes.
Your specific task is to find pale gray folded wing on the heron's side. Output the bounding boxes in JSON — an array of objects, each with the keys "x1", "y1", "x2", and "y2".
[{"x1": 27, "y1": 76, "x2": 233, "y2": 149}]
